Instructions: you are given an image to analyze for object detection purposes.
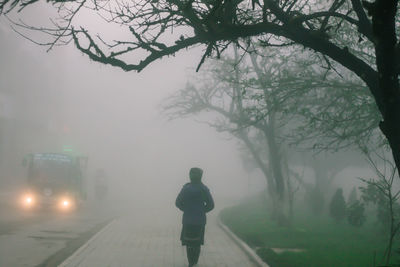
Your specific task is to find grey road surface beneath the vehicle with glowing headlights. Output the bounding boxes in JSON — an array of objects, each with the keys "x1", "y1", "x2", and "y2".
[{"x1": 0, "y1": 203, "x2": 110, "y2": 267}]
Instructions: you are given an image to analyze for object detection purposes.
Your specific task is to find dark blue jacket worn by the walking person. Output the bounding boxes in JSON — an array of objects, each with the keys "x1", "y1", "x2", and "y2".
[{"x1": 175, "y1": 183, "x2": 214, "y2": 225}]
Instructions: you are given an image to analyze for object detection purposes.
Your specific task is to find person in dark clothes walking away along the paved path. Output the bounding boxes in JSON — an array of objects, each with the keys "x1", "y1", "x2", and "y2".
[{"x1": 175, "y1": 168, "x2": 214, "y2": 267}]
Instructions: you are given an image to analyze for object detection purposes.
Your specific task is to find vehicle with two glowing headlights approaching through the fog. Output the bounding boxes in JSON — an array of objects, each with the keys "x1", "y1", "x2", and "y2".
[{"x1": 21, "y1": 153, "x2": 88, "y2": 211}]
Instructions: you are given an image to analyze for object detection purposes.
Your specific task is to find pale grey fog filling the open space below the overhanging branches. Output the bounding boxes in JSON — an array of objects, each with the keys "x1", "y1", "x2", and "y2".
[{"x1": 0, "y1": 10, "x2": 264, "y2": 218}]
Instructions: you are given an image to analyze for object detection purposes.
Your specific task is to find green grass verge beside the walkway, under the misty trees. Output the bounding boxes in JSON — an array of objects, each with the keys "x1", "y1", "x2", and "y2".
[{"x1": 221, "y1": 195, "x2": 400, "y2": 267}]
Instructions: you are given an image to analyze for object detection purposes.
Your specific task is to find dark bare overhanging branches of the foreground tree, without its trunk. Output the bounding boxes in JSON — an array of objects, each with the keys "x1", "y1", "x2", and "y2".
[{"x1": 0, "y1": 0, "x2": 377, "y2": 78}]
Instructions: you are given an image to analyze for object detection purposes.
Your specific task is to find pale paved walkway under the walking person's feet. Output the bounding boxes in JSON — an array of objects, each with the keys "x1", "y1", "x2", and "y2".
[{"x1": 61, "y1": 206, "x2": 255, "y2": 267}]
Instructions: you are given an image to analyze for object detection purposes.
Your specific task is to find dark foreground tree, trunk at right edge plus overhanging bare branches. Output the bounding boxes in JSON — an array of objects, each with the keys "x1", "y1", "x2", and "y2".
[{"x1": 0, "y1": 0, "x2": 400, "y2": 174}]
